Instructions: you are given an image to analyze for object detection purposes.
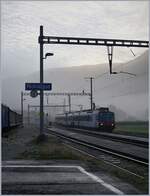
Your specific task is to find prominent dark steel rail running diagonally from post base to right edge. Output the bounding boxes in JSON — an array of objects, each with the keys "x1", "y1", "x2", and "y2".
[{"x1": 47, "y1": 128, "x2": 148, "y2": 166}]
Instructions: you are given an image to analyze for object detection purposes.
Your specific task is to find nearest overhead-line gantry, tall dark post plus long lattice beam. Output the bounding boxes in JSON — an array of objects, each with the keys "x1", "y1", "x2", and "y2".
[{"x1": 38, "y1": 25, "x2": 149, "y2": 135}]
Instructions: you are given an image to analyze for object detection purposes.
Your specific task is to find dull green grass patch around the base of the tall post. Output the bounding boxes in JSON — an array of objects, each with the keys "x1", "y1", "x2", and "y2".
[{"x1": 17, "y1": 137, "x2": 91, "y2": 160}]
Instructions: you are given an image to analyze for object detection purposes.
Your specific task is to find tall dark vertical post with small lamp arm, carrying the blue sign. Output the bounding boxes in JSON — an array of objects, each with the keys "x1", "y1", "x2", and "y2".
[{"x1": 39, "y1": 26, "x2": 53, "y2": 139}]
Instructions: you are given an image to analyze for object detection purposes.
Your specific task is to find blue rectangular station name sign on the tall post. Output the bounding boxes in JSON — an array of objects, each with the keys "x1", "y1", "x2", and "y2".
[{"x1": 25, "y1": 83, "x2": 52, "y2": 91}]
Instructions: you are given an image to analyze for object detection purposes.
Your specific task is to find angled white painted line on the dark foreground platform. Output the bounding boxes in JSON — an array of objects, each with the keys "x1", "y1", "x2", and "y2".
[{"x1": 2, "y1": 165, "x2": 124, "y2": 195}]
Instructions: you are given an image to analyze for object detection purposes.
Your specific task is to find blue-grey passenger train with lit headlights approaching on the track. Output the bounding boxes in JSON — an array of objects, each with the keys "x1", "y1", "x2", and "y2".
[{"x1": 55, "y1": 107, "x2": 115, "y2": 131}]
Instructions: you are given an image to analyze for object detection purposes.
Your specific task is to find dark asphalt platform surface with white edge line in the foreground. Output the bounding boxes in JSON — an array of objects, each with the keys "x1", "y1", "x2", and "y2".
[{"x1": 2, "y1": 161, "x2": 137, "y2": 195}]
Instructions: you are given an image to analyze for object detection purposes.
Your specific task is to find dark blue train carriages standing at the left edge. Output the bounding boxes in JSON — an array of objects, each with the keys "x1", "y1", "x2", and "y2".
[{"x1": 1, "y1": 104, "x2": 22, "y2": 134}]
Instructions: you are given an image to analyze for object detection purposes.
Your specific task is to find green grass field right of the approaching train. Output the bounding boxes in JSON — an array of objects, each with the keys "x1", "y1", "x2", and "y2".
[{"x1": 114, "y1": 121, "x2": 149, "y2": 137}]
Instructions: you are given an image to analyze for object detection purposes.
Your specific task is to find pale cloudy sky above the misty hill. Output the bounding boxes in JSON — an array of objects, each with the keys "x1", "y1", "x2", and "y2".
[{"x1": 1, "y1": 1, "x2": 149, "y2": 79}]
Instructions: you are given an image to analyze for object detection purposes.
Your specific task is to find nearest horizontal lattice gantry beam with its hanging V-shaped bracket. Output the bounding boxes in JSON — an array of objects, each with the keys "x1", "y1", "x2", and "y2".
[{"x1": 39, "y1": 36, "x2": 149, "y2": 74}]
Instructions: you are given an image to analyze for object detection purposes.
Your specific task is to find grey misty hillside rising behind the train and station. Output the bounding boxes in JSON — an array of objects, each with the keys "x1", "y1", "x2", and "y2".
[{"x1": 2, "y1": 50, "x2": 148, "y2": 121}]
